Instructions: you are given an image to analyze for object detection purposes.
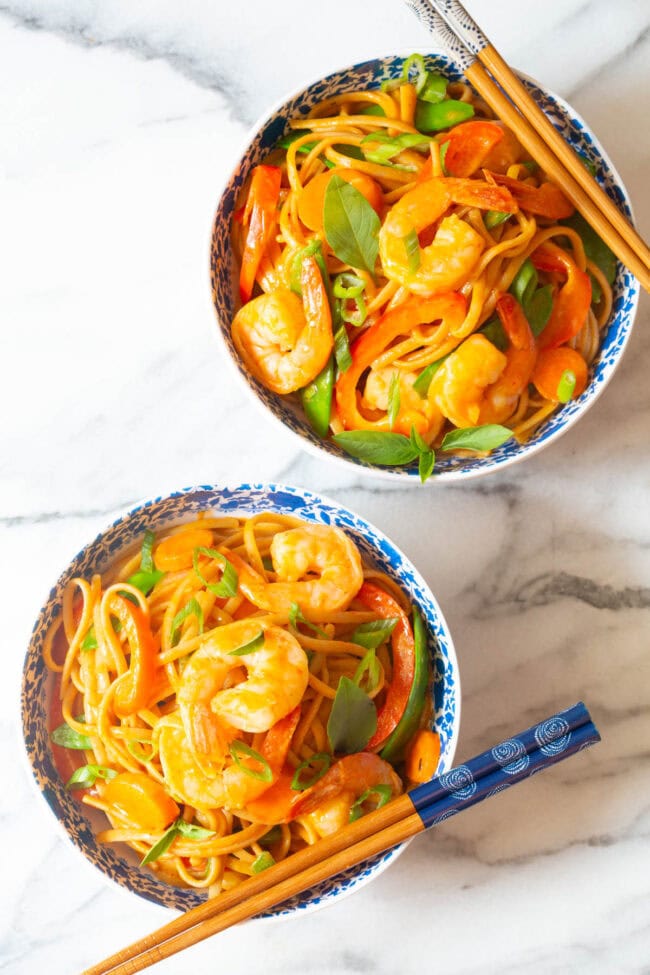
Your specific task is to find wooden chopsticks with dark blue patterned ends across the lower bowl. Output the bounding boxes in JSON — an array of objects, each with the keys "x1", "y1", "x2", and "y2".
[{"x1": 83, "y1": 703, "x2": 600, "y2": 975}]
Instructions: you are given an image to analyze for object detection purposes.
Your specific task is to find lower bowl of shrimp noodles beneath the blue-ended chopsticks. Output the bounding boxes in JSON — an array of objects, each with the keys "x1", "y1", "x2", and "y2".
[{"x1": 22, "y1": 485, "x2": 460, "y2": 917}]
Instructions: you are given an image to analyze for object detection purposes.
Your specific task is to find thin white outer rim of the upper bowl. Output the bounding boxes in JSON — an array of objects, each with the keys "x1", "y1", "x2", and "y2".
[{"x1": 207, "y1": 45, "x2": 641, "y2": 488}]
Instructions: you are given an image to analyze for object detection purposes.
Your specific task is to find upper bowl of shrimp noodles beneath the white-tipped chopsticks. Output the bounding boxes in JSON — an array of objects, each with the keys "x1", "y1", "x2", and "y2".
[{"x1": 211, "y1": 54, "x2": 639, "y2": 482}]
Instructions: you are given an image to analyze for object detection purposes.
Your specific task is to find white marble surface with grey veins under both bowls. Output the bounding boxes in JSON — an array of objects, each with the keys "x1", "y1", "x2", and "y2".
[{"x1": 0, "y1": 0, "x2": 650, "y2": 975}]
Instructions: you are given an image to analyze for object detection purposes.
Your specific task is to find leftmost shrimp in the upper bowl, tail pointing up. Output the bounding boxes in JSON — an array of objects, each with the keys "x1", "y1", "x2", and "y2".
[{"x1": 232, "y1": 257, "x2": 334, "y2": 393}]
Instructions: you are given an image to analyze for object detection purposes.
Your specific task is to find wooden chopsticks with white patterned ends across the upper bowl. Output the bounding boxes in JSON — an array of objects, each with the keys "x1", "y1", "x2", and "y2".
[{"x1": 406, "y1": 0, "x2": 650, "y2": 291}]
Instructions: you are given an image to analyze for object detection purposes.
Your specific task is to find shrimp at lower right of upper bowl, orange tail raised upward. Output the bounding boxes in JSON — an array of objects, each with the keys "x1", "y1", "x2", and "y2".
[{"x1": 430, "y1": 294, "x2": 537, "y2": 428}]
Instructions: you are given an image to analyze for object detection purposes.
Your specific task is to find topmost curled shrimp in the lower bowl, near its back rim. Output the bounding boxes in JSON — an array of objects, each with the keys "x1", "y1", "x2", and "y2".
[{"x1": 225, "y1": 525, "x2": 363, "y2": 616}]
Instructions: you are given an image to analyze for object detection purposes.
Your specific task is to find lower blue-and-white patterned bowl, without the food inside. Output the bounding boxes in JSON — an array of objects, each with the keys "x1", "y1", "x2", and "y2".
[{"x1": 21, "y1": 484, "x2": 460, "y2": 918}]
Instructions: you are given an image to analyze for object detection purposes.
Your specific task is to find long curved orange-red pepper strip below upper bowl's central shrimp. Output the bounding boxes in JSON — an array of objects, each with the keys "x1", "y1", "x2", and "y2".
[{"x1": 335, "y1": 291, "x2": 467, "y2": 437}]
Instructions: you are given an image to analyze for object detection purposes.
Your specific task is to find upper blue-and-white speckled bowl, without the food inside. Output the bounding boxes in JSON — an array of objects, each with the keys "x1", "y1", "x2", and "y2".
[{"x1": 210, "y1": 54, "x2": 639, "y2": 483}]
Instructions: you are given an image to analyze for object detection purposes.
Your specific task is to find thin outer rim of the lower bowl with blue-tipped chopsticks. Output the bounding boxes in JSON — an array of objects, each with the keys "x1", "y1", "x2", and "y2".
[{"x1": 18, "y1": 481, "x2": 462, "y2": 923}]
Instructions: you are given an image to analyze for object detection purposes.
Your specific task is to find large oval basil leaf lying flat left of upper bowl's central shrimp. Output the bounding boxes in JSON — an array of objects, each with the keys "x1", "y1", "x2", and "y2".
[{"x1": 323, "y1": 176, "x2": 380, "y2": 276}]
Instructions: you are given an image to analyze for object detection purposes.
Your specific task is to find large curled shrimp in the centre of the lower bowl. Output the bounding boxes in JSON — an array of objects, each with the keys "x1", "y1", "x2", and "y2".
[{"x1": 176, "y1": 619, "x2": 309, "y2": 768}]
